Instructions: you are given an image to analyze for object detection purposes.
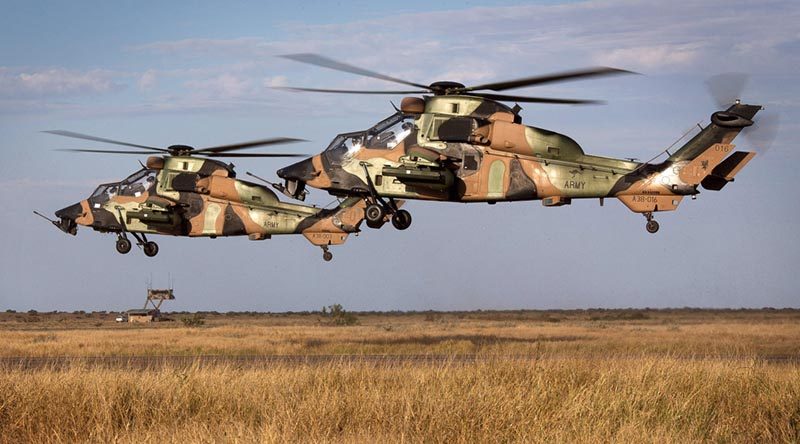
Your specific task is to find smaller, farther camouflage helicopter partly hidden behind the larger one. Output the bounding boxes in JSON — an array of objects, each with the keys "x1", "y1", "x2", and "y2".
[{"x1": 34, "y1": 131, "x2": 372, "y2": 261}]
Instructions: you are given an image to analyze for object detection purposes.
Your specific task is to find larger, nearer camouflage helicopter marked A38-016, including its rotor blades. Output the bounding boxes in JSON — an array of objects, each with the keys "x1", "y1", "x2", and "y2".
[{"x1": 277, "y1": 54, "x2": 762, "y2": 233}]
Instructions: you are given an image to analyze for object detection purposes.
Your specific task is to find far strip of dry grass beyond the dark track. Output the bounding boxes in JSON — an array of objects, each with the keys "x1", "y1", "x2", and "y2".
[{"x1": 0, "y1": 311, "x2": 800, "y2": 357}]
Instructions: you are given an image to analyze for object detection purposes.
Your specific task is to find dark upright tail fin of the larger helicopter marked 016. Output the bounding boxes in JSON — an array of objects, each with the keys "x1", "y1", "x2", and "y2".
[{"x1": 667, "y1": 103, "x2": 761, "y2": 162}]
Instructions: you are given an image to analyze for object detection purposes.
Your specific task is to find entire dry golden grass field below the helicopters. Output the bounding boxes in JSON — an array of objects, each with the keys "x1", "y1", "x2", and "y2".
[{"x1": 0, "y1": 310, "x2": 800, "y2": 442}]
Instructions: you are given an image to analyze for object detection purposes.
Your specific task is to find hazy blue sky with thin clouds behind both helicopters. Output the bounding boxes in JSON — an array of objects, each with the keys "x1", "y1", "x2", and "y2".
[{"x1": 0, "y1": 0, "x2": 800, "y2": 312}]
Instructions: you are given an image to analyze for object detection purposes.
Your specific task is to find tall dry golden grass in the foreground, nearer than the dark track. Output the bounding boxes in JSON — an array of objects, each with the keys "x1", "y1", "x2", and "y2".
[{"x1": 0, "y1": 358, "x2": 800, "y2": 442}]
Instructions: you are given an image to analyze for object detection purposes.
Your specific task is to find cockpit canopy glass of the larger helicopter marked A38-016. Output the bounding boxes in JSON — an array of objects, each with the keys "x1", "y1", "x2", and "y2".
[{"x1": 325, "y1": 112, "x2": 416, "y2": 164}]
